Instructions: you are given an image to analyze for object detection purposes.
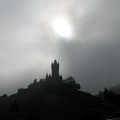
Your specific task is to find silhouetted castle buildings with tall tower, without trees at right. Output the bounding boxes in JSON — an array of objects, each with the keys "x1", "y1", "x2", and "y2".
[{"x1": 18, "y1": 60, "x2": 63, "y2": 93}]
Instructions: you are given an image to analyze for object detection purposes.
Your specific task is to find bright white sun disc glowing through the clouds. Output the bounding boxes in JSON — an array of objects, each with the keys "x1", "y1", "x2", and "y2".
[{"x1": 53, "y1": 18, "x2": 72, "y2": 38}]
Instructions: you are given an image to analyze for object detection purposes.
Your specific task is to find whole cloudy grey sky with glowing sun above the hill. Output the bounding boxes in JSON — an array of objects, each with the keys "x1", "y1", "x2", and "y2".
[{"x1": 0, "y1": 0, "x2": 120, "y2": 95}]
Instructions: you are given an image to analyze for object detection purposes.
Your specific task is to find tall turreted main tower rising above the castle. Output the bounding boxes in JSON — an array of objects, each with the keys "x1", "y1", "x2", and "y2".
[{"x1": 51, "y1": 60, "x2": 59, "y2": 77}]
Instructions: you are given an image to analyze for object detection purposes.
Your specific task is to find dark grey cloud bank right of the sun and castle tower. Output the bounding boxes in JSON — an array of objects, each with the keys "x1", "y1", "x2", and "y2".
[{"x1": 57, "y1": 1, "x2": 120, "y2": 93}]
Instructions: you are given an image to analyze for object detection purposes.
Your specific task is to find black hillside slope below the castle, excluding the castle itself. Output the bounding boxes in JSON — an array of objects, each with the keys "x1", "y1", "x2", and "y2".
[{"x1": 0, "y1": 87, "x2": 117, "y2": 120}]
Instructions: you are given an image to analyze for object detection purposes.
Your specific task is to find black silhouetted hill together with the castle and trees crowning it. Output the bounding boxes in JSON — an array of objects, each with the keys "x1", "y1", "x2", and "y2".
[{"x1": 0, "y1": 60, "x2": 119, "y2": 120}]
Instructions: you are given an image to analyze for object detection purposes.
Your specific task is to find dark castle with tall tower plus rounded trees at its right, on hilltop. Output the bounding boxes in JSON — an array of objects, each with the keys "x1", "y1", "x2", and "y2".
[{"x1": 18, "y1": 60, "x2": 80, "y2": 94}]
